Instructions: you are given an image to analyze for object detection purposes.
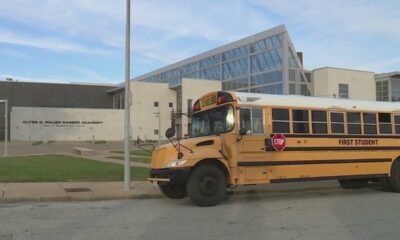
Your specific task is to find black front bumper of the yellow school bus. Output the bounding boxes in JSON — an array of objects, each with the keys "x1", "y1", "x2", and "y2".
[{"x1": 147, "y1": 168, "x2": 190, "y2": 185}]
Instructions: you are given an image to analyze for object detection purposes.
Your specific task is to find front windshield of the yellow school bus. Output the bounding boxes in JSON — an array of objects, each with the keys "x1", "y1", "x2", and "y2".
[{"x1": 190, "y1": 105, "x2": 234, "y2": 137}]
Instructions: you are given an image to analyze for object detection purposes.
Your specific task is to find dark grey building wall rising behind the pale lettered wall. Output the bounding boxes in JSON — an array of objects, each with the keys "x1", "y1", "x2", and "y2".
[{"x1": 0, "y1": 81, "x2": 115, "y2": 139}]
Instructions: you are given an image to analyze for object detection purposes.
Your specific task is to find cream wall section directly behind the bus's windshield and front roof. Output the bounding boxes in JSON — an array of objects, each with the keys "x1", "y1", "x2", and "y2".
[{"x1": 181, "y1": 78, "x2": 222, "y2": 137}]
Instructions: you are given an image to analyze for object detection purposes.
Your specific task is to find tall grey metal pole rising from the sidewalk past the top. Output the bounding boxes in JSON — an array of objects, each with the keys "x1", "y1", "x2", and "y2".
[{"x1": 124, "y1": 0, "x2": 131, "y2": 191}]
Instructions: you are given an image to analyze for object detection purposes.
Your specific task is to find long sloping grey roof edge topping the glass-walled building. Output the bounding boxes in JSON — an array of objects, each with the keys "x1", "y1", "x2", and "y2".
[{"x1": 132, "y1": 24, "x2": 287, "y2": 81}]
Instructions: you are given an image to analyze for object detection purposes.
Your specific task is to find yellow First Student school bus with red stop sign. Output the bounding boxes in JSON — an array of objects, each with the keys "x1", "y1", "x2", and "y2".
[{"x1": 149, "y1": 91, "x2": 400, "y2": 206}]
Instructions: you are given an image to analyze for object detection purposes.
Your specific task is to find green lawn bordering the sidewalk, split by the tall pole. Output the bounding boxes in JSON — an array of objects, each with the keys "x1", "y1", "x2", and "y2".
[{"x1": 0, "y1": 155, "x2": 149, "y2": 182}]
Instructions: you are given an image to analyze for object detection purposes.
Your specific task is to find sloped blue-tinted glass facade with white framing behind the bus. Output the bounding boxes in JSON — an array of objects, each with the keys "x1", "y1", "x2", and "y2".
[{"x1": 138, "y1": 29, "x2": 311, "y2": 95}]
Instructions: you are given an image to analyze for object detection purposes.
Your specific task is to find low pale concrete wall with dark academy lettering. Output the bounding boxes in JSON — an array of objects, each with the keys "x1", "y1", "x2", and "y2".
[{"x1": 10, "y1": 107, "x2": 124, "y2": 141}]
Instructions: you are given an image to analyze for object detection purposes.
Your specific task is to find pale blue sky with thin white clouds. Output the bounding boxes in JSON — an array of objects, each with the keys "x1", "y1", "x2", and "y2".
[{"x1": 0, "y1": 0, "x2": 400, "y2": 83}]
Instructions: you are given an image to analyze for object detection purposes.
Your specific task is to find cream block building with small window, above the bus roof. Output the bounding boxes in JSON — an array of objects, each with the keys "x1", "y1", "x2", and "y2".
[{"x1": 313, "y1": 68, "x2": 376, "y2": 101}]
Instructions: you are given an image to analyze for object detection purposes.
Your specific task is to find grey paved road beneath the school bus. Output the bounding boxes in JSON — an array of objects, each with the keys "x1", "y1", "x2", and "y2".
[{"x1": 0, "y1": 182, "x2": 400, "y2": 240}]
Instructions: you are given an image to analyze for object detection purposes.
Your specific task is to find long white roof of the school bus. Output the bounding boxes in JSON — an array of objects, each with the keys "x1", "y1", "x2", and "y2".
[{"x1": 230, "y1": 92, "x2": 400, "y2": 112}]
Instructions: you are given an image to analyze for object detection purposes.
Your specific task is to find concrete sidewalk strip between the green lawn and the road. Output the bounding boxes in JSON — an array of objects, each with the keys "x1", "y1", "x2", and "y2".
[{"x1": 0, "y1": 181, "x2": 162, "y2": 203}]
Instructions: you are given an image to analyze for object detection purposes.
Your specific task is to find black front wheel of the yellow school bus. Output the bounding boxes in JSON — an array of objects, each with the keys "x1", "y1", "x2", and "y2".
[{"x1": 186, "y1": 165, "x2": 227, "y2": 207}]
